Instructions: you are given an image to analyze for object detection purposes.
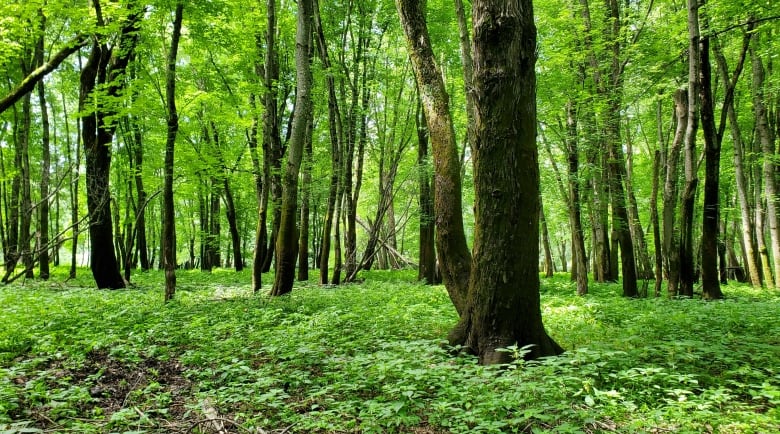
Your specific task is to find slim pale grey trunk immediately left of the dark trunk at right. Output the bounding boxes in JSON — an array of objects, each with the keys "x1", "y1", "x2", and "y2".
[{"x1": 678, "y1": 0, "x2": 700, "y2": 297}]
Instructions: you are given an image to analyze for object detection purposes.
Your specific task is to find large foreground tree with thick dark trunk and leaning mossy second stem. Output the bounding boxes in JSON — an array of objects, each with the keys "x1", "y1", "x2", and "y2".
[{"x1": 396, "y1": 0, "x2": 562, "y2": 364}]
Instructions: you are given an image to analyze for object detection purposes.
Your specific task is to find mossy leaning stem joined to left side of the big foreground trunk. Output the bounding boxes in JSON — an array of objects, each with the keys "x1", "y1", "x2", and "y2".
[{"x1": 396, "y1": 0, "x2": 470, "y2": 315}]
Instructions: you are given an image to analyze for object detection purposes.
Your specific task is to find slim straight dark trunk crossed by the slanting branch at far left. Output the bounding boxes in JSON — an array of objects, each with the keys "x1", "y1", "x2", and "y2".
[{"x1": 35, "y1": 11, "x2": 51, "y2": 280}]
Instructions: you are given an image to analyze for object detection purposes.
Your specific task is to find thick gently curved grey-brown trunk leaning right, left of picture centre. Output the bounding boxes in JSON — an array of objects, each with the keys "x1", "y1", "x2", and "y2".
[{"x1": 271, "y1": 0, "x2": 314, "y2": 296}]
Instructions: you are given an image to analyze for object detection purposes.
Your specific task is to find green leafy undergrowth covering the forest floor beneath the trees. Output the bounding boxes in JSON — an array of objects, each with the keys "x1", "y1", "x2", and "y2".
[{"x1": 0, "y1": 269, "x2": 780, "y2": 434}]
